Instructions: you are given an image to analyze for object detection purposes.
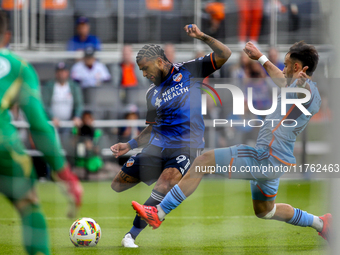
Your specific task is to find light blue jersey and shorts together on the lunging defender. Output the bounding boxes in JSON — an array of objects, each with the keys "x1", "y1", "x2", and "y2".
[{"x1": 214, "y1": 80, "x2": 321, "y2": 201}]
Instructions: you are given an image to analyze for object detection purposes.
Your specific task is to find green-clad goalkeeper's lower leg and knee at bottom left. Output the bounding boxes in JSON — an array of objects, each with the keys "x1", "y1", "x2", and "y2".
[{"x1": 14, "y1": 190, "x2": 50, "y2": 255}]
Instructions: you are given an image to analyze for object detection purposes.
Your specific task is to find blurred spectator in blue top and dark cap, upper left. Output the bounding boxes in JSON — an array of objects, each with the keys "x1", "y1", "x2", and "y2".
[{"x1": 67, "y1": 16, "x2": 101, "y2": 51}]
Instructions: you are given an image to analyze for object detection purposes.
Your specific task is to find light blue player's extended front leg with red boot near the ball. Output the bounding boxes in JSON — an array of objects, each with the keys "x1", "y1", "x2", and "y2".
[{"x1": 132, "y1": 151, "x2": 215, "y2": 229}]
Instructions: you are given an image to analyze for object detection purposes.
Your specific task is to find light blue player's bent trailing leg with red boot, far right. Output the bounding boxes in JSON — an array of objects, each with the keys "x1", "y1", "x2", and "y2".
[{"x1": 253, "y1": 200, "x2": 332, "y2": 241}]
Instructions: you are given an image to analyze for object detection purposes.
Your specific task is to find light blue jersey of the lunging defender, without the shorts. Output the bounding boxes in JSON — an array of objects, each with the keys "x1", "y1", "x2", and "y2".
[{"x1": 255, "y1": 80, "x2": 321, "y2": 165}]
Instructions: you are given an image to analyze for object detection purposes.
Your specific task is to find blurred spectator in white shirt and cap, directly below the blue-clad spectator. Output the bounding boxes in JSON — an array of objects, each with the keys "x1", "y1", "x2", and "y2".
[{"x1": 71, "y1": 46, "x2": 111, "y2": 88}]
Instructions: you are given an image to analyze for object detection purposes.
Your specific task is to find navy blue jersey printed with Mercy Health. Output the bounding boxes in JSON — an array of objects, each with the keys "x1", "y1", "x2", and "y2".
[{"x1": 146, "y1": 53, "x2": 216, "y2": 148}]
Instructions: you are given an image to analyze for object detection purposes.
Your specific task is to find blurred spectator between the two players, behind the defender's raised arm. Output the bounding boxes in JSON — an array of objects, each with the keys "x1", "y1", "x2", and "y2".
[{"x1": 244, "y1": 61, "x2": 272, "y2": 117}]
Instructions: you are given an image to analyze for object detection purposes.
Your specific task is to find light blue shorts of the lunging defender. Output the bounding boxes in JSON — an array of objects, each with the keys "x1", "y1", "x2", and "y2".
[{"x1": 214, "y1": 144, "x2": 284, "y2": 201}]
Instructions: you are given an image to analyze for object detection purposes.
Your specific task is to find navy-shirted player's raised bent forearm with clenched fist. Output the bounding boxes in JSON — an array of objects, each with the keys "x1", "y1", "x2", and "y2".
[{"x1": 184, "y1": 24, "x2": 231, "y2": 68}]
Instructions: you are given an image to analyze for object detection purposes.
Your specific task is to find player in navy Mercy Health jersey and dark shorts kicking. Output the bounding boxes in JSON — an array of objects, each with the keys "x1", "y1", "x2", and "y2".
[{"x1": 111, "y1": 24, "x2": 231, "y2": 248}]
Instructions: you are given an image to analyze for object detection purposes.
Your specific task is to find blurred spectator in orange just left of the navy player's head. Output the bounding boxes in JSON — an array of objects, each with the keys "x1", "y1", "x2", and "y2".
[{"x1": 112, "y1": 45, "x2": 147, "y2": 104}]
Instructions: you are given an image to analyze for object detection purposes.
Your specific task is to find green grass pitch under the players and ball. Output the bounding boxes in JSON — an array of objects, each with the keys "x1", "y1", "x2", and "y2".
[{"x1": 0, "y1": 179, "x2": 327, "y2": 255}]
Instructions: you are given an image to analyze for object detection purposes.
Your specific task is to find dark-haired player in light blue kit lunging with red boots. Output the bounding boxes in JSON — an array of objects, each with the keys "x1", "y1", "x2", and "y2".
[{"x1": 132, "y1": 42, "x2": 332, "y2": 241}]
